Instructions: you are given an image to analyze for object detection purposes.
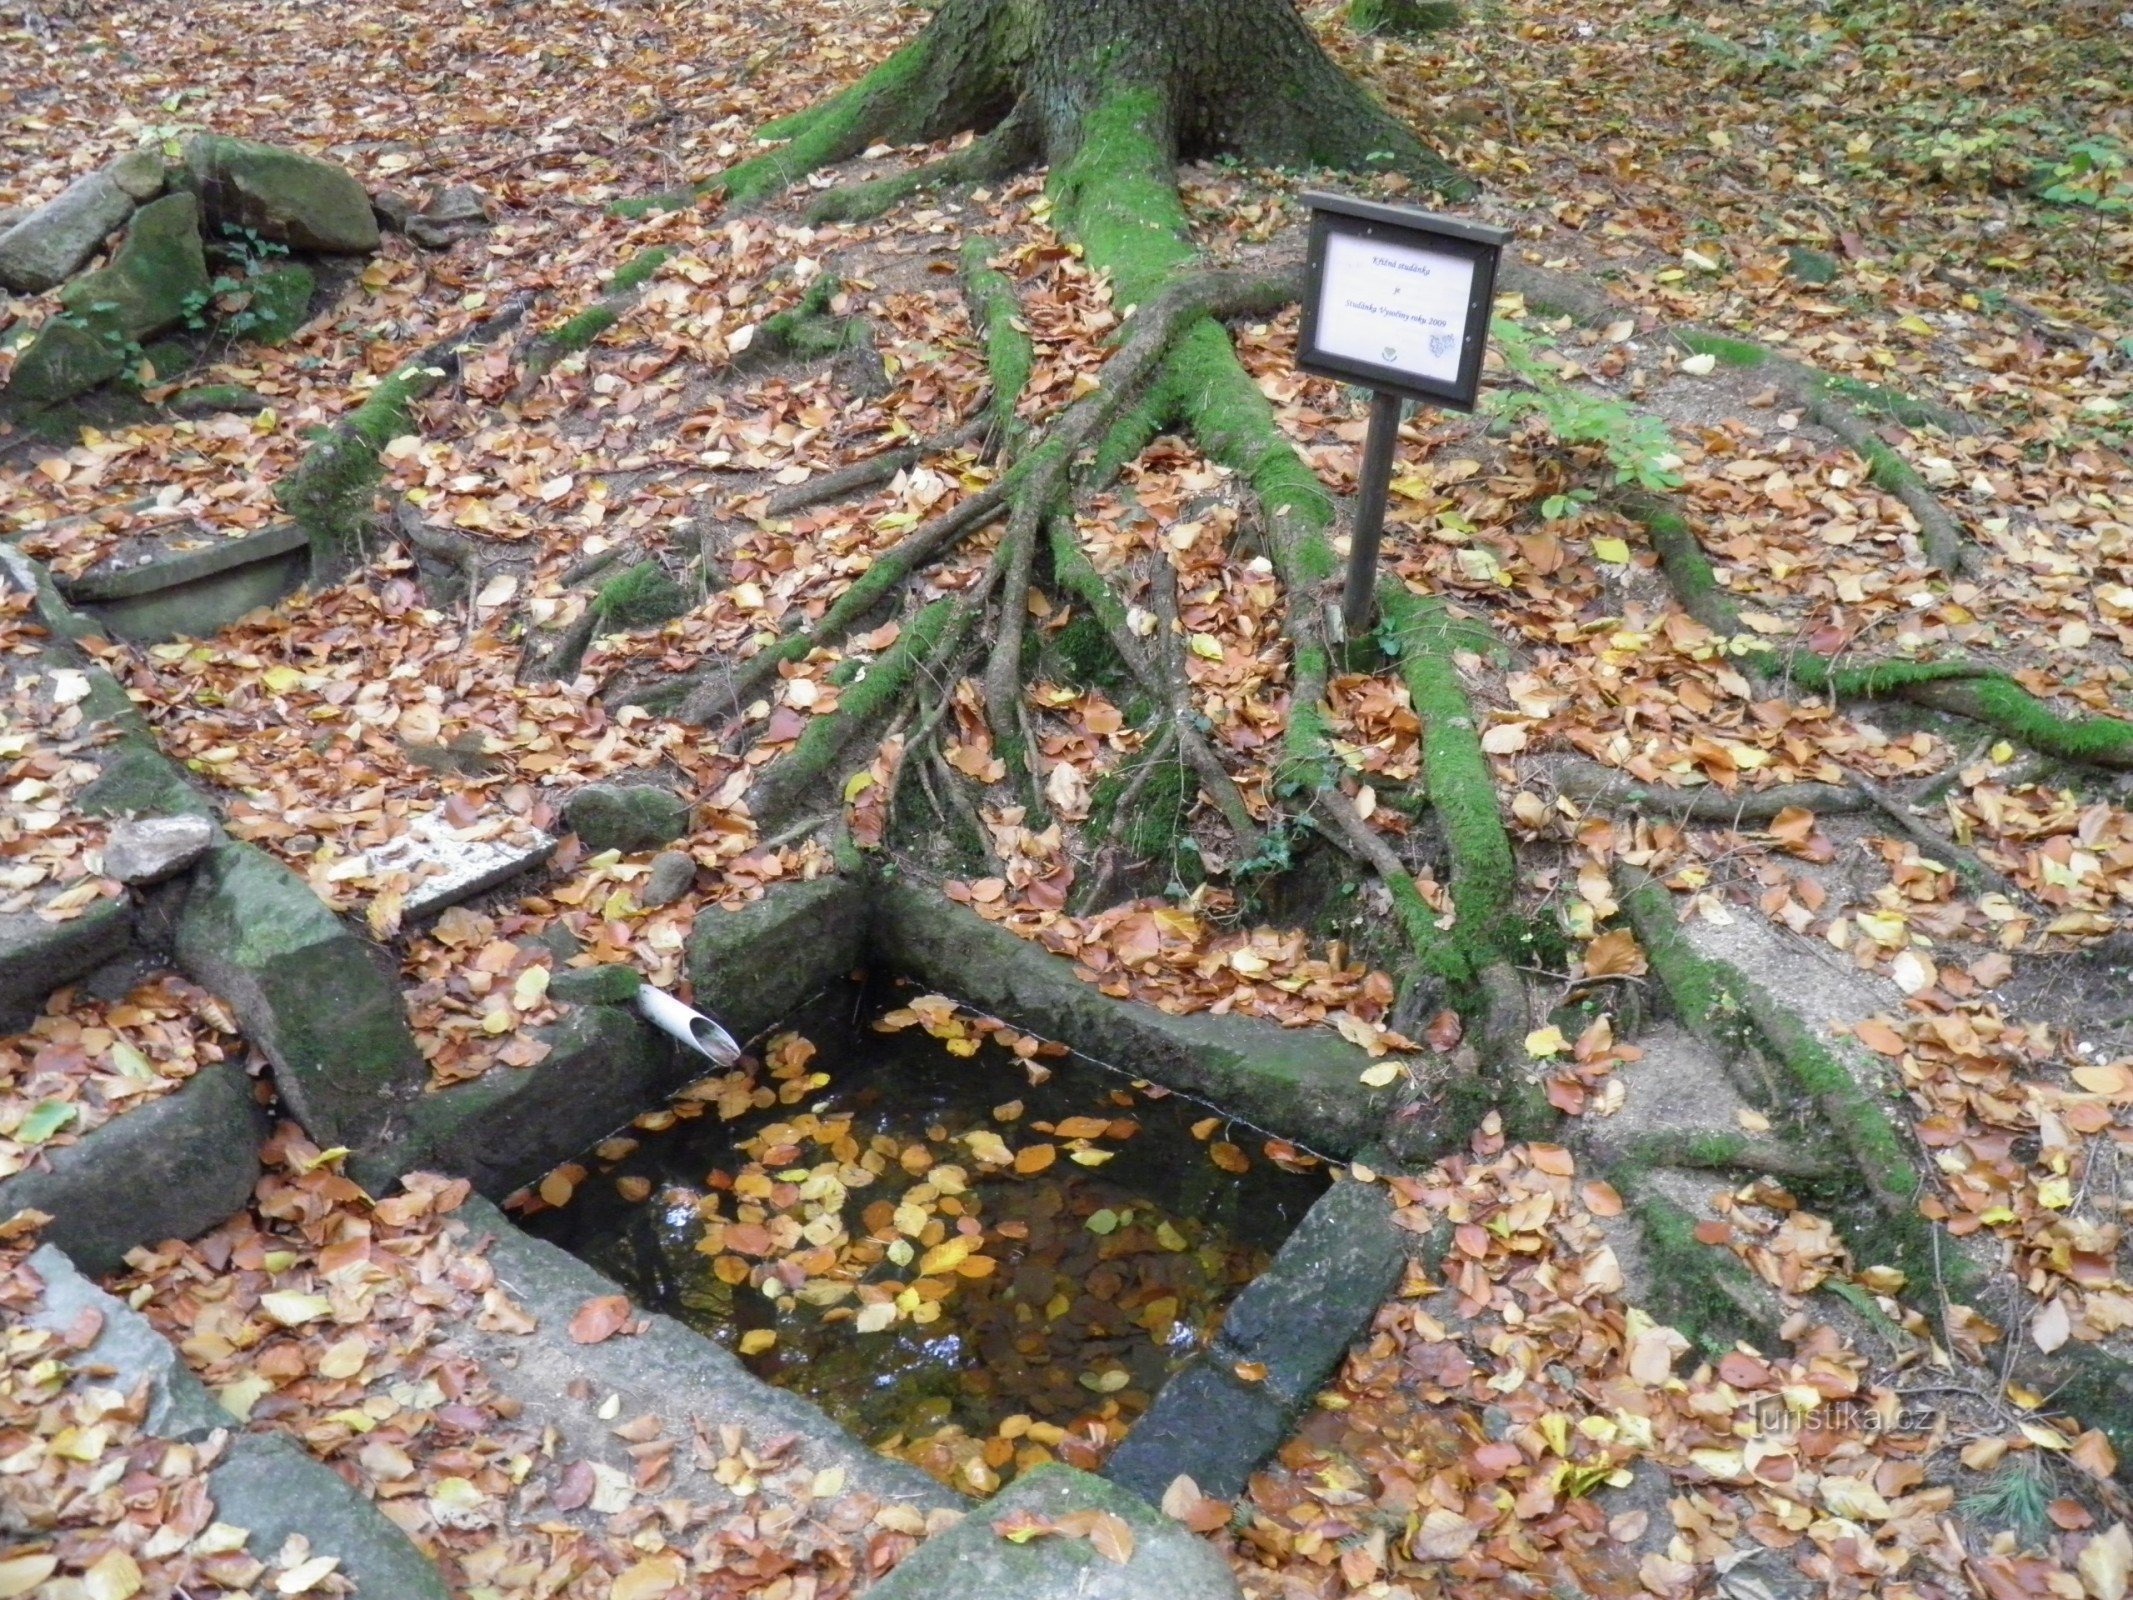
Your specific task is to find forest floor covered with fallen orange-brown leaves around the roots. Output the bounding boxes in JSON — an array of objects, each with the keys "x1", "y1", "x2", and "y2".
[{"x1": 0, "y1": 4, "x2": 2133, "y2": 1600}]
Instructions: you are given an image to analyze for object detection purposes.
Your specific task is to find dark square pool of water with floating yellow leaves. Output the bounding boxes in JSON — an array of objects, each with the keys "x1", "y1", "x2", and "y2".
[{"x1": 525, "y1": 986, "x2": 1327, "y2": 1491}]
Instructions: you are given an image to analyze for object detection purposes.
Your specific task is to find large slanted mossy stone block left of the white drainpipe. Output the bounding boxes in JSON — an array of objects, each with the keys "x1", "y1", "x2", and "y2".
[{"x1": 175, "y1": 841, "x2": 429, "y2": 1146}]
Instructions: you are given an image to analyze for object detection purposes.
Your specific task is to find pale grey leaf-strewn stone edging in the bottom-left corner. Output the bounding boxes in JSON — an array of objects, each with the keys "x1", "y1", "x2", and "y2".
[{"x1": 30, "y1": 1244, "x2": 446, "y2": 1600}]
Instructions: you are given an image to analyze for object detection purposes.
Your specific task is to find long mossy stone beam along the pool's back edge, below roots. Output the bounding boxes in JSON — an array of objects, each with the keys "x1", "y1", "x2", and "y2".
[{"x1": 868, "y1": 881, "x2": 1391, "y2": 1156}]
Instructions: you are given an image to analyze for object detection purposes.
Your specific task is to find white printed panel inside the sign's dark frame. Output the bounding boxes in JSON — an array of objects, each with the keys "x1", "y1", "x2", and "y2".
[{"x1": 1318, "y1": 233, "x2": 1474, "y2": 384}]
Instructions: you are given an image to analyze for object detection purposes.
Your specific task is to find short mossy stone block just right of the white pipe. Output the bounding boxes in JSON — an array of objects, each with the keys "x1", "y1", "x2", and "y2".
[{"x1": 689, "y1": 877, "x2": 866, "y2": 1043}]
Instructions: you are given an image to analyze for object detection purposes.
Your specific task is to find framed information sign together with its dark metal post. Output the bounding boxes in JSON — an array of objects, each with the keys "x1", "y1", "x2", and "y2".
[{"x1": 1297, "y1": 192, "x2": 1510, "y2": 640}]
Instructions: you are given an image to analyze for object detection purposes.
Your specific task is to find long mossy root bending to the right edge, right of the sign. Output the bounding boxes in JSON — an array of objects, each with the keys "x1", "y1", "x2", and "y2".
[{"x1": 1621, "y1": 495, "x2": 2133, "y2": 772}]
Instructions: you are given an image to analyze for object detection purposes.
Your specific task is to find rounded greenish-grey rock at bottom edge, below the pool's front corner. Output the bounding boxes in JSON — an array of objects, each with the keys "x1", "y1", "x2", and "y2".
[{"x1": 866, "y1": 1463, "x2": 1239, "y2": 1600}]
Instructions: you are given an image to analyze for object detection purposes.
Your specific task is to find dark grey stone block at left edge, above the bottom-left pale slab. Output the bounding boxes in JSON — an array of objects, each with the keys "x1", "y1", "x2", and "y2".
[{"x1": 0, "y1": 1060, "x2": 267, "y2": 1274}]
